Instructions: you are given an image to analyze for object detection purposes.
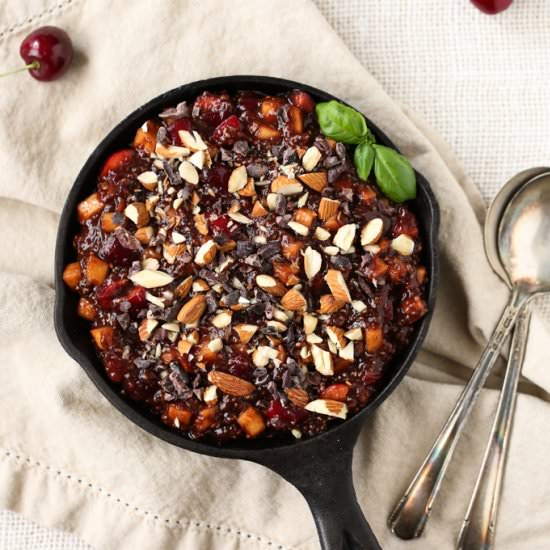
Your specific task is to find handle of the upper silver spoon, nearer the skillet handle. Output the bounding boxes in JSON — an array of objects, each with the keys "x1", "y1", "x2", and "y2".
[{"x1": 388, "y1": 285, "x2": 529, "y2": 539}]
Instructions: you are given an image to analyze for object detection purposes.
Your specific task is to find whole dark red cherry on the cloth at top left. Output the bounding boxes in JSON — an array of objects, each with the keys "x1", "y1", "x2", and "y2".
[{"x1": 19, "y1": 27, "x2": 73, "y2": 82}]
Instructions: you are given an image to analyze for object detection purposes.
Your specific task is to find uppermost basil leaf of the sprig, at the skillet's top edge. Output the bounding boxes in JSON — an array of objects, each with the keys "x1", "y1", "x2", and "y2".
[{"x1": 315, "y1": 100, "x2": 370, "y2": 144}]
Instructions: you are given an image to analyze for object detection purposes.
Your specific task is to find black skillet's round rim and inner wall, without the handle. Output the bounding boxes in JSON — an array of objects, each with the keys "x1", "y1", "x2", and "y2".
[{"x1": 54, "y1": 75, "x2": 439, "y2": 462}]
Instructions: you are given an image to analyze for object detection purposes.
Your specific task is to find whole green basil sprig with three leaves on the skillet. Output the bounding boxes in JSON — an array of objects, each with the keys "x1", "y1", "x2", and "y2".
[{"x1": 315, "y1": 100, "x2": 416, "y2": 202}]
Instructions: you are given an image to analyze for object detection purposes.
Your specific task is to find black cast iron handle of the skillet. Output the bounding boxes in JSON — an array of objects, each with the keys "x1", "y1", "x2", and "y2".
[{"x1": 262, "y1": 426, "x2": 381, "y2": 550}]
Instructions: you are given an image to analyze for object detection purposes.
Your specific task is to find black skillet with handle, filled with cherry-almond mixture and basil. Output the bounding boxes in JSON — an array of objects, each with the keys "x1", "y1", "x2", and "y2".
[{"x1": 56, "y1": 77, "x2": 438, "y2": 548}]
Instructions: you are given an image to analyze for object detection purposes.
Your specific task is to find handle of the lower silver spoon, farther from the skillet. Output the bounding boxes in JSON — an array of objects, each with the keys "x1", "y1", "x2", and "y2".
[{"x1": 456, "y1": 305, "x2": 531, "y2": 550}]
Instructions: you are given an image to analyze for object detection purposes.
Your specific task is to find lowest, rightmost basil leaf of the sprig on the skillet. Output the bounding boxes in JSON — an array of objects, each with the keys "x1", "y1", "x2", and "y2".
[{"x1": 373, "y1": 145, "x2": 416, "y2": 202}]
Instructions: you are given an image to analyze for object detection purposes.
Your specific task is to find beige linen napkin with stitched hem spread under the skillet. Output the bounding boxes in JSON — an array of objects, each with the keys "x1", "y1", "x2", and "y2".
[{"x1": 0, "y1": 0, "x2": 550, "y2": 550}]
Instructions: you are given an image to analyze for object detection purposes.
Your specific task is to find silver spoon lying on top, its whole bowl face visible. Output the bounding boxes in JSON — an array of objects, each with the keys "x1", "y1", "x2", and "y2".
[{"x1": 388, "y1": 173, "x2": 550, "y2": 539}]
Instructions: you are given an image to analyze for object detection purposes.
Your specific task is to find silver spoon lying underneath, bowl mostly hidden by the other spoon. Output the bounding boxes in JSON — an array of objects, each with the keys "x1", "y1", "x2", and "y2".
[{"x1": 456, "y1": 168, "x2": 550, "y2": 550}]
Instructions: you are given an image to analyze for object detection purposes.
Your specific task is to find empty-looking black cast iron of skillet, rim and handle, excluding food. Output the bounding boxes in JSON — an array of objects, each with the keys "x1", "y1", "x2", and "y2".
[{"x1": 55, "y1": 76, "x2": 439, "y2": 550}]
